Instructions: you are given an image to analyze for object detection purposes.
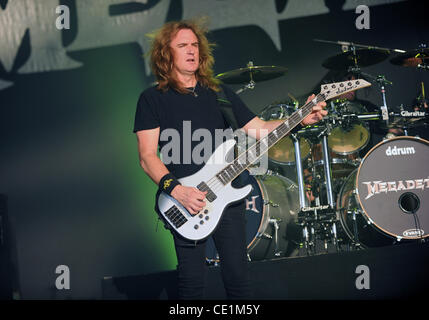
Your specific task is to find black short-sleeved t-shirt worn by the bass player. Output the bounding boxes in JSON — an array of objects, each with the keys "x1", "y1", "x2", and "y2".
[{"x1": 134, "y1": 84, "x2": 255, "y2": 178}]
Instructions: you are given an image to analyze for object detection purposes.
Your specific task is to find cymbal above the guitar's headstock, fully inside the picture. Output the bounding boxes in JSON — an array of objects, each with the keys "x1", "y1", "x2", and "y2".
[{"x1": 322, "y1": 49, "x2": 390, "y2": 70}]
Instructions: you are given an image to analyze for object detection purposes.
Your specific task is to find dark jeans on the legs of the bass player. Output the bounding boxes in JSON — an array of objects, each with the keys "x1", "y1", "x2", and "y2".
[{"x1": 173, "y1": 201, "x2": 251, "y2": 300}]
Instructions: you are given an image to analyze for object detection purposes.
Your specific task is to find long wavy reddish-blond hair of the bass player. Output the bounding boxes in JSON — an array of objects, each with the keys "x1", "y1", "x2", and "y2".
[{"x1": 149, "y1": 20, "x2": 220, "y2": 93}]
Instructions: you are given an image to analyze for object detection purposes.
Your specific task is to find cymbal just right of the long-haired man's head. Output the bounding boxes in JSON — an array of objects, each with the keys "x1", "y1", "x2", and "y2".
[{"x1": 216, "y1": 66, "x2": 287, "y2": 84}]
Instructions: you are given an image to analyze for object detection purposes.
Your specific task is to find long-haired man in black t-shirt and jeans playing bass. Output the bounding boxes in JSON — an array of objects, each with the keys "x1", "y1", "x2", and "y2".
[{"x1": 134, "y1": 21, "x2": 327, "y2": 299}]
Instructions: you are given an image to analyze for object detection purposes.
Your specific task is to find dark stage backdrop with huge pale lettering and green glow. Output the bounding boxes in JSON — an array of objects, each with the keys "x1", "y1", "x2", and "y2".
[{"x1": 0, "y1": 0, "x2": 429, "y2": 299}]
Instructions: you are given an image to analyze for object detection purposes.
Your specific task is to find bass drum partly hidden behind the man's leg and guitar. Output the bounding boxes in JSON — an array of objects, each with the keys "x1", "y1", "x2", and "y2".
[{"x1": 206, "y1": 174, "x2": 302, "y2": 264}]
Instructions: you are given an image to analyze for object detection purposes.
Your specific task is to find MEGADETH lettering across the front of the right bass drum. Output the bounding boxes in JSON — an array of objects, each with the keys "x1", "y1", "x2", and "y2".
[{"x1": 362, "y1": 177, "x2": 429, "y2": 200}]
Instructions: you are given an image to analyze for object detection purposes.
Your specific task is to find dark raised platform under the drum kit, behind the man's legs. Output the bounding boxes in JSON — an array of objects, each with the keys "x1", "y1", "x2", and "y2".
[{"x1": 102, "y1": 242, "x2": 429, "y2": 300}]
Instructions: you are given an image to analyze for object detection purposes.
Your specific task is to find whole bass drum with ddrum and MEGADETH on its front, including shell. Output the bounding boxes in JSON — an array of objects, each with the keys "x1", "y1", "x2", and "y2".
[{"x1": 337, "y1": 137, "x2": 429, "y2": 247}]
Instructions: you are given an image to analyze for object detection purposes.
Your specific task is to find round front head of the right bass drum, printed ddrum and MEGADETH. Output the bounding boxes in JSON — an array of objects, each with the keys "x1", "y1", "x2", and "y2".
[{"x1": 356, "y1": 137, "x2": 429, "y2": 240}]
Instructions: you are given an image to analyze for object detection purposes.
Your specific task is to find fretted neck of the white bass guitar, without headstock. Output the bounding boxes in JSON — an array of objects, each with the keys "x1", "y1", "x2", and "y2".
[{"x1": 216, "y1": 93, "x2": 325, "y2": 185}]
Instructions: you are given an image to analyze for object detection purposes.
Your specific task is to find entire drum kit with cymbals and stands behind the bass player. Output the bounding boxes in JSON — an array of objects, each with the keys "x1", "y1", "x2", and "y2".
[{"x1": 206, "y1": 40, "x2": 429, "y2": 265}]
